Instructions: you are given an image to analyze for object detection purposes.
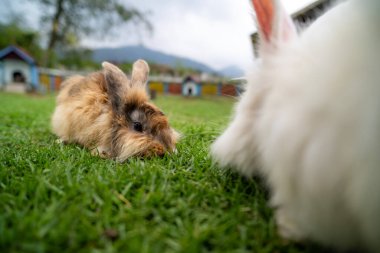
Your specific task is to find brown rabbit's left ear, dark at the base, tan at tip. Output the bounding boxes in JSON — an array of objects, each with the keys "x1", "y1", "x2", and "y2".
[{"x1": 102, "y1": 62, "x2": 130, "y2": 112}]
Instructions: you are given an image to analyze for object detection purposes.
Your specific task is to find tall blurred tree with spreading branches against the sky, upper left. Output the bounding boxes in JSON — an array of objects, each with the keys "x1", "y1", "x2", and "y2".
[{"x1": 36, "y1": 0, "x2": 152, "y2": 65}]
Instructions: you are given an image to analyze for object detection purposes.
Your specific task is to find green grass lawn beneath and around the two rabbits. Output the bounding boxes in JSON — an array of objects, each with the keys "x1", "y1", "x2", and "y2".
[{"x1": 0, "y1": 93, "x2": 326, "y2": 252}]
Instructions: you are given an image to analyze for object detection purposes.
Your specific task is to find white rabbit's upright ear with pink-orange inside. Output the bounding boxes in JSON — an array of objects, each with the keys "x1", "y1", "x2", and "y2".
[{"x1": 252, "y1": 0, "x2": 297, "y2": 53}]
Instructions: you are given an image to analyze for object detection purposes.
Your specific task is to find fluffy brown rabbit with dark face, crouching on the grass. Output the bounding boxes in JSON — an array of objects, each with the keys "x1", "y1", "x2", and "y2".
[{"x1": 52, "y1": 60, "x2": 179, "y2": 161}]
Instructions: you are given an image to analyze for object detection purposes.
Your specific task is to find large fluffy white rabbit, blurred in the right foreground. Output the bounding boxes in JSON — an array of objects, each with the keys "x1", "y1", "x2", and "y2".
[{"x1": 211, "y1": 0, "x2": 380, "y2": 252}]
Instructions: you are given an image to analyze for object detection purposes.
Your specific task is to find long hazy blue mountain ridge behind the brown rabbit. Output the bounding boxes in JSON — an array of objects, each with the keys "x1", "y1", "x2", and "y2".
[{"x1": 93, "y1": 46, "x2": 217, "y2": 73}]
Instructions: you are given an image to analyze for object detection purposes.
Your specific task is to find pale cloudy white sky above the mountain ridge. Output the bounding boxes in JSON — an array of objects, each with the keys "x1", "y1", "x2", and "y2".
[{"x1": 0, "y1": 0, "x2": 313, "y2": 70}]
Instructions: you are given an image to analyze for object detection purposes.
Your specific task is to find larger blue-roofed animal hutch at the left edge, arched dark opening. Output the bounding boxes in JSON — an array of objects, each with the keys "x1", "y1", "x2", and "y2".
[{"x1": 0, "y1": 46, "x2": 39, "y2": 91}]
